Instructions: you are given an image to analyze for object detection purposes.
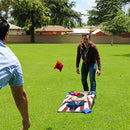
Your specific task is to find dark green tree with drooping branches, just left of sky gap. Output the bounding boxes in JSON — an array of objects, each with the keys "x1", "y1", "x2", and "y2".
[{"x1": 42, "y1": 0, "x2": 82, "y2": 28}]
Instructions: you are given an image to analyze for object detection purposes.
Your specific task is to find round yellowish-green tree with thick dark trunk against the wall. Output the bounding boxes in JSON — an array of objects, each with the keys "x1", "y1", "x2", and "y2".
[{"x1": 12, "y1": 0, "x2": 49, "y2": 43}]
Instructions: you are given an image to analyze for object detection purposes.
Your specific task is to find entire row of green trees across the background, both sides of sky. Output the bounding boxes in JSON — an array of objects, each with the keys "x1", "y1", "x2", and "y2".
[{"x1": 0, "y1": 0, "x2": 130, "y2": 43}]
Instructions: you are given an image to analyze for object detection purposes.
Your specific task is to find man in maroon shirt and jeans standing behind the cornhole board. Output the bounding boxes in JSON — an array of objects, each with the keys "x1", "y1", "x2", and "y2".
[{"x1": 76, "y1": 33, "x2": 101, "y2": 92}]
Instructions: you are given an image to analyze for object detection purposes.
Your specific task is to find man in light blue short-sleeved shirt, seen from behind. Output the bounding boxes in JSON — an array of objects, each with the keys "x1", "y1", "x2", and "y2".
[{"x1": 0, "y1": 17, "x2": 31, "y2": 130}]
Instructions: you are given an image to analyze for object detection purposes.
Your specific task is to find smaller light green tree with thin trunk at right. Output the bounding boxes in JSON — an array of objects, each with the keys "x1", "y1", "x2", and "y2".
[{"x1": 102, "y1": 10, "x2": 130, "y2": 45}]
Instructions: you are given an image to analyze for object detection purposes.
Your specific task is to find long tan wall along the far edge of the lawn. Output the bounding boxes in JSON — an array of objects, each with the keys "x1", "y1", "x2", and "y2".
[{"x1": 7, "y1": 35, "x2": 130, "y2": 44}]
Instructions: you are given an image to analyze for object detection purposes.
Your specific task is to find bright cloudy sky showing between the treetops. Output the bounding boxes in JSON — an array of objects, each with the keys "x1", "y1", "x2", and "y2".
[{"x1": 70, "y1": 0, "x2": 130, "y2": 23}]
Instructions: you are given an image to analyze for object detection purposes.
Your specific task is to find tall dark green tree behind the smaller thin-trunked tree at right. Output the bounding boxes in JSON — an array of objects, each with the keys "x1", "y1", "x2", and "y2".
[{"x1": 87, "y1": 0, "x2": 122, "y2": 26}]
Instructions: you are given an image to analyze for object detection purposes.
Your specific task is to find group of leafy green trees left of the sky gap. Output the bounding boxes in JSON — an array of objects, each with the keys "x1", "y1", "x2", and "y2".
[{"x1": 0, "y1": 0, "x2": 82, "y2": 43}]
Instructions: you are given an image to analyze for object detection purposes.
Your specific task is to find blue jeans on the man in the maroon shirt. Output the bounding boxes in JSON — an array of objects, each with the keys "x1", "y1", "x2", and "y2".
[{"x1": 81, "y1": 63, "x2": 97, "y2": 91}]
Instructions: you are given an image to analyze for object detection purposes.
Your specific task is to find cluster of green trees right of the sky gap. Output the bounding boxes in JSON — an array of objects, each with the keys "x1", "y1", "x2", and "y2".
[{"x1": 87, "y1": 0, "x2": 130, "y2": 45}]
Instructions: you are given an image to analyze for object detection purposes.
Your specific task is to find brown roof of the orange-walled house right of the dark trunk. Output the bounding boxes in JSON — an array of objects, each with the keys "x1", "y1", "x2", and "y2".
[{"x1": 36, "y1": 25, "x2": 72, "y2": 32}]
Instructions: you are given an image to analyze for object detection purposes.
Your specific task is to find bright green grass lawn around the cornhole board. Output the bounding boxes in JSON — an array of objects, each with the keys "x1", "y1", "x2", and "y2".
[{"x1": 0, "y1": 44, "x2": 130, "y2": 130}]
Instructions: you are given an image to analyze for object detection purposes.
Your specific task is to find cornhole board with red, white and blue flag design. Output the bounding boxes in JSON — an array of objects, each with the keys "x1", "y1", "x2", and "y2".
[{"x1": 57, "y1": 91, "x2": 95, "y2": 112}]
